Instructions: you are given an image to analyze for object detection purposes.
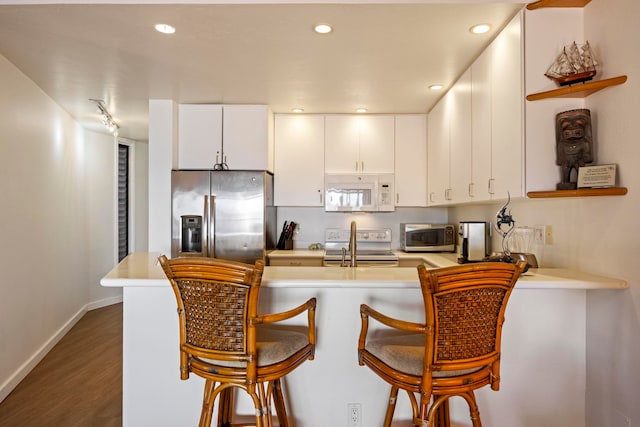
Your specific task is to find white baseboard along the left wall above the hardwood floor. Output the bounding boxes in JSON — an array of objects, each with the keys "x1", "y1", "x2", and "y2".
[{"x1": 0, "y1": 295, "x2": 122, "y2": 402}]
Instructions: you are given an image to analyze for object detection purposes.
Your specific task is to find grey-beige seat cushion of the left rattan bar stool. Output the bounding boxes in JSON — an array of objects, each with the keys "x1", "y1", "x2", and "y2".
[{"x1": 199, "y1": 325, "x2": 309, "y2": 368}]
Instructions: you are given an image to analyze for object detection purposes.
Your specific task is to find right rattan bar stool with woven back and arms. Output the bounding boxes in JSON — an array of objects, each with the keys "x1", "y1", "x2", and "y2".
[{"x1": 358, "y1": 261, "x2": 526, "y2": 427}]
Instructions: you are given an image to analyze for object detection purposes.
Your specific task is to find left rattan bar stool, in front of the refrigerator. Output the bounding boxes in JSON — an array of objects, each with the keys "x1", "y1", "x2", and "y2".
[{"x1": 159, "y1": 255, "x2": 316, "y2": 427}]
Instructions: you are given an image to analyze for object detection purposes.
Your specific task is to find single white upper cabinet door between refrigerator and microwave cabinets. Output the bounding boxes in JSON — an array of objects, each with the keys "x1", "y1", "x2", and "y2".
[{"x1": 274, "y1": 114, "x2": 324, "y2": 206}]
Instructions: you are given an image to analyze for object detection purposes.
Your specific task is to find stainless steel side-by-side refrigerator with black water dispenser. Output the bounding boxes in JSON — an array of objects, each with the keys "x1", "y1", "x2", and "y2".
[{"x1": 171, "y1": 170, "x2": 276, "y2": 264}]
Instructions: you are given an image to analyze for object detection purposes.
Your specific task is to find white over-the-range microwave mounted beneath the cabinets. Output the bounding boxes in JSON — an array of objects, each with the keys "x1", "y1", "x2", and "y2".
[{"x1": 324, "y1": 174, "x2": 395, "y2": 212}]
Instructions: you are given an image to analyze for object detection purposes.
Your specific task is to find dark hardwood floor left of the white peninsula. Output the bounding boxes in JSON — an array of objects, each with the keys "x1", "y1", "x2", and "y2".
[{"x1": 0, "y1": 304, "x2": 122, "y2": 427}]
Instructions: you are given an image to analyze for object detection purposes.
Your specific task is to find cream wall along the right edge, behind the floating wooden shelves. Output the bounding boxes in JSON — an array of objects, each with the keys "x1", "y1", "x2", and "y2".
[{"x1": 450, "y1": 0, "x2": 640, "y2": 427}]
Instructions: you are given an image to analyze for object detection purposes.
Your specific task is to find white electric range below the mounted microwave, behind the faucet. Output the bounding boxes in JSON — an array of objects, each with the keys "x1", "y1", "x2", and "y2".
[{"x1": 324, "y1": 228, "x2": 398, "y2": 267}]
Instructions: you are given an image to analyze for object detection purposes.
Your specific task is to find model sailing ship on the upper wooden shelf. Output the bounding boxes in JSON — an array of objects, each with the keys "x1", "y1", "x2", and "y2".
[{"x1": 544, "y1": 42, "x2": 597, "y2": 86}]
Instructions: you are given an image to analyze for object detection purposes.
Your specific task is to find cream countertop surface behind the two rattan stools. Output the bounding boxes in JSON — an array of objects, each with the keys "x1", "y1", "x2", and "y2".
[{"x1": 100, "y1": 251, "x2": 629, "y2": 289}]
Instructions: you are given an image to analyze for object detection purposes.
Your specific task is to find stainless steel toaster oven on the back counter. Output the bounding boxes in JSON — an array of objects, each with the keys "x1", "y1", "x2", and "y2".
[{"x1": 400, "y1": 223, "x2": 456, "y2": 252}]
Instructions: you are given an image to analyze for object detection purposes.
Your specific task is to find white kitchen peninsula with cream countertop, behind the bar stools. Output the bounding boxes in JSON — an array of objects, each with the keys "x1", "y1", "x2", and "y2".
[{"x1": 101, "y1": 253, "x2": 627, "y2": 427}]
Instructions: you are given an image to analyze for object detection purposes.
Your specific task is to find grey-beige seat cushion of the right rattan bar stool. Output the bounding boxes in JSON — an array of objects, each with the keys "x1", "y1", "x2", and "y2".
[{"x1": 365, "y1": 334, "x2": 482, "y2": 378}]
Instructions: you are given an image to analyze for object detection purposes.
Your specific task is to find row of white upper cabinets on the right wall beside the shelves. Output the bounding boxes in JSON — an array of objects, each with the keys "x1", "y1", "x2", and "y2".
[{"x1": 428, "y1": 14, "x2": 524, "y2": 206}]
